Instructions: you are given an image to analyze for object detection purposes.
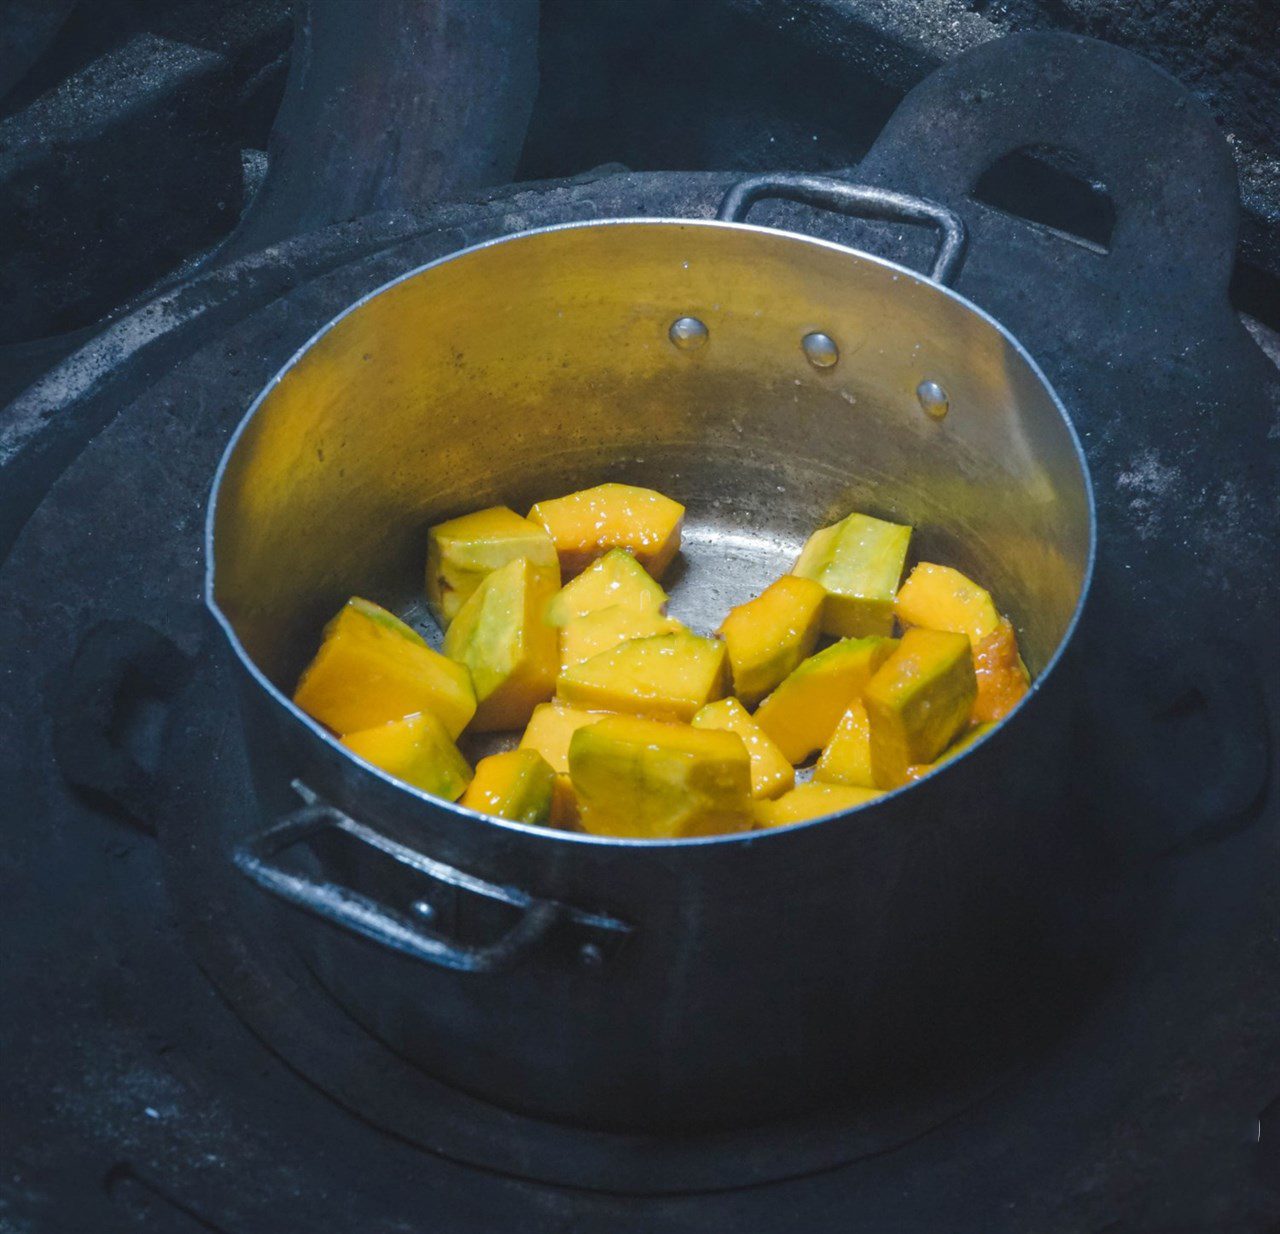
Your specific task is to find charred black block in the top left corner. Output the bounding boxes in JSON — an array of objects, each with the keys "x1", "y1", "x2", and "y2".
[{"x1": 0, "y1": 4, "x2": 287, "y2": 355}]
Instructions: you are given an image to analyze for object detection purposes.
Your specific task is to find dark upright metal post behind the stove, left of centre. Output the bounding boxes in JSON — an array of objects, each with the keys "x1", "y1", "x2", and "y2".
[{"x1": 227, "y1": 0, "x2": 538, "y2": 255}]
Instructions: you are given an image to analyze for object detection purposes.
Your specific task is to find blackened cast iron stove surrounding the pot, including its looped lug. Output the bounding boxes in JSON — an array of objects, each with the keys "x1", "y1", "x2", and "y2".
[{"x1": 0, "y1": 9, "x2": 1280, "y2": 1234}]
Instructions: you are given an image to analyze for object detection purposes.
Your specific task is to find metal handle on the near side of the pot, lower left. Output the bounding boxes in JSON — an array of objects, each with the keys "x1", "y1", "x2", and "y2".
[{"x1": 233, "y1": 803, "x2": 630, "y2": 973}]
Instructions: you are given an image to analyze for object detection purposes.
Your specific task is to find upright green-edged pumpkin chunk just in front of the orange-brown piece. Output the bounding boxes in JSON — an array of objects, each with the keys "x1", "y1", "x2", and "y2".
[{"x1": 863, "y1": 626, "x2": 978, "y2": 789}]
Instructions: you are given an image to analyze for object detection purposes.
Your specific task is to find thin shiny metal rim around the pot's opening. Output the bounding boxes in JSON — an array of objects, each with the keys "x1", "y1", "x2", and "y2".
[{"x1": 204, "y1": 216, "x2": 1098, "y2": 850}]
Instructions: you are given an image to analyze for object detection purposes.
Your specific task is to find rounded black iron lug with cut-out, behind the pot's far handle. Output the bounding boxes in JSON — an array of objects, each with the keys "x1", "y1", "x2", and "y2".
[{"x1": 856, "y1": 33, "x2": 1239, "y2": 303}]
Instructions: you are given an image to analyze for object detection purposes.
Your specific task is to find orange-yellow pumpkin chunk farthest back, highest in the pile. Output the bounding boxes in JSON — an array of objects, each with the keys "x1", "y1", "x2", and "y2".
[{"x1": 529, "y1": 484, "x2": 685, "y2": 579}]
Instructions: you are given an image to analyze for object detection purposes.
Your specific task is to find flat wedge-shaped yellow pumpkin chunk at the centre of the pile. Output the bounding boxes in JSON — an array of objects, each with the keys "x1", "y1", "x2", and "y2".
[{"x1": 556, "y1": 630, "x2": 727, "y2": 722}]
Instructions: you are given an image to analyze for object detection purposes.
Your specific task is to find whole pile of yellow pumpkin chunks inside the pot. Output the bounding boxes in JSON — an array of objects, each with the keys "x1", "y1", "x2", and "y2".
[{"x1": 294, "y1": 484, "x2": 1028, "y2": 840}]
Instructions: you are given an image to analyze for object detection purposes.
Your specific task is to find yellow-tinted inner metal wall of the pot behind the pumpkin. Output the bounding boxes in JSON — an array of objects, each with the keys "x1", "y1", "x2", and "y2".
[{"x1": 214, "y1": 221, "x2": 1089, "y2": 693}]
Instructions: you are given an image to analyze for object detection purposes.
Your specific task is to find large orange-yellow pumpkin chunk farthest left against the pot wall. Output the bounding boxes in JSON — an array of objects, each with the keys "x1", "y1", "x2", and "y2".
[{"x1": 293, "y1": 597, "x2": 476, "y2": 737}]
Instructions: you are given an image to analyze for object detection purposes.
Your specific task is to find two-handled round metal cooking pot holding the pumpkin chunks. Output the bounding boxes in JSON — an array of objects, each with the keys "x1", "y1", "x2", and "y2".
[{"x1": 207, "y1": 177, "x2": 1094, "y2": 1129}]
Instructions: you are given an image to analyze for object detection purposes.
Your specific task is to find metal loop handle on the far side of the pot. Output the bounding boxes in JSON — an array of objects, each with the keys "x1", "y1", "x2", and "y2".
[{"x1": 716, "y1": 173, "x2": 969, "y2": 287}]
